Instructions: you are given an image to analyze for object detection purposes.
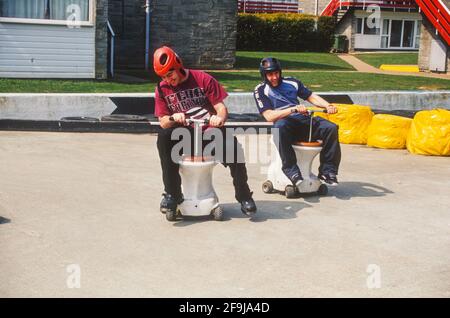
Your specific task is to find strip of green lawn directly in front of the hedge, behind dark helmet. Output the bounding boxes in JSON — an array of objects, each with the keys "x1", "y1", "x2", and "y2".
[{"x1": 235, "y1": 51, "x2": 354, "y2": 71}]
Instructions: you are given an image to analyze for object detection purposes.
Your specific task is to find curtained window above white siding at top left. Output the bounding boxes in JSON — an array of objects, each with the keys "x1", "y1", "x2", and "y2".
[{"x1": 0, "y1": 0, "x2": 93, "y2": 22}]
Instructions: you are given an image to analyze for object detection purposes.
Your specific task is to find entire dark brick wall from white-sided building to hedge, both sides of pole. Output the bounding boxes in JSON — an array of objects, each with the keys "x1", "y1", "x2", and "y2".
[{"x1": 109, "y1": 0, "x2": 237, "y2": 69}]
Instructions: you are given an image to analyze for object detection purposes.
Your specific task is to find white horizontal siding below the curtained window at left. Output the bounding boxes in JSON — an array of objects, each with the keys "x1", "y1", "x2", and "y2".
[{"x1": 0, "y1": 23, "x2": 95, "y2": 78}]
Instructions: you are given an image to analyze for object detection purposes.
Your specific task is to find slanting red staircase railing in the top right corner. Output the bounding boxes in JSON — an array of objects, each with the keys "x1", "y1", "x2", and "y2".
[{"x1": 416, "y1": 0, "x2": 450, "y2": 45}]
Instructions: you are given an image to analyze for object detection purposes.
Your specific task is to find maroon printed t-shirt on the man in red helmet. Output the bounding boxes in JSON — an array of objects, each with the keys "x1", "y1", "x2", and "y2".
[{"x1": 155, "y1": 70, "x2": 228, "y2": 117}]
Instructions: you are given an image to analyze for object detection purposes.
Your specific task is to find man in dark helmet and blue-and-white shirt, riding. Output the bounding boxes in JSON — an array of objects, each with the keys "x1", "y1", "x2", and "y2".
[{"x1": 254, "y1": 57, "x2": 341, "y2": 187}]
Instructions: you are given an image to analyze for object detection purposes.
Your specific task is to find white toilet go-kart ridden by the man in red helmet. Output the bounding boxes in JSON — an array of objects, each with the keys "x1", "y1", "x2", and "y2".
[{"x1": 166, "y1": 118, "x2": 223, "y2": 221}]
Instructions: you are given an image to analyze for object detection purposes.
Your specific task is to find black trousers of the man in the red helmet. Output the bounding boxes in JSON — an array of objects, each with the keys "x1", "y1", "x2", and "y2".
[{"x1": 157, "y1": 127, "x2": 252, "y2": 202}]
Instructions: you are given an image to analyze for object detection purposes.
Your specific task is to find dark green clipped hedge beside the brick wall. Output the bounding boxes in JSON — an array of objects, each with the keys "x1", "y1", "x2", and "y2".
[{"x1": 237, "y1": 13, "x2": 336, "y2": 52}]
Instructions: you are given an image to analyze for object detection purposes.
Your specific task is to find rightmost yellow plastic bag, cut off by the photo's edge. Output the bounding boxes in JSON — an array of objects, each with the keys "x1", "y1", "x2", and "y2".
[{"x1": 406, "y1": 109, "x2": 450, "y2": 156}]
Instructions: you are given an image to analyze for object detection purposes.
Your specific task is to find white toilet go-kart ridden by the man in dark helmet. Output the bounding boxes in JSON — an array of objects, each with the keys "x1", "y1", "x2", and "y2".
[{"x1": 262, "y1": 109, "x2": 328, "y2": 198}]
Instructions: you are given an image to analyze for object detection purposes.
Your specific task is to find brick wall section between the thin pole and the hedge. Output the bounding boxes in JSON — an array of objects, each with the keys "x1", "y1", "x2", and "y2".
[{"x1": 150, "y1": 0, "x2": 237, "y2": 69}]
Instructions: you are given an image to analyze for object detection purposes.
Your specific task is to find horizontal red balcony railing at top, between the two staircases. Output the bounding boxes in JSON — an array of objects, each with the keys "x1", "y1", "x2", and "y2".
[{"x1": 322, "y1": 0, "x2": 416, "y2": 16}]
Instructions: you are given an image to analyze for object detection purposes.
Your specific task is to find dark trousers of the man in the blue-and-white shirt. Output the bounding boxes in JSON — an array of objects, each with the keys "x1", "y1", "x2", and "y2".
[{"x1": 274, "y1": 114, "x2": 341, "y2": 182}]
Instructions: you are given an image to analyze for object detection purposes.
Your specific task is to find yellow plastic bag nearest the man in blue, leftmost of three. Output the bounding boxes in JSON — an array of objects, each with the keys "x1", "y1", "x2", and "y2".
[{"x1": 328, "y1": 104, "x2": 373, "y2": 145}]
